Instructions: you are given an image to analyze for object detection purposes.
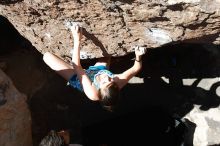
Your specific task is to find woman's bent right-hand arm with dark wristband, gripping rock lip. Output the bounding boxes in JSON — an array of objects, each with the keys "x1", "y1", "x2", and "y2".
[{"x1": 117, "y1": 47, "x2": 146, "y2": 89}]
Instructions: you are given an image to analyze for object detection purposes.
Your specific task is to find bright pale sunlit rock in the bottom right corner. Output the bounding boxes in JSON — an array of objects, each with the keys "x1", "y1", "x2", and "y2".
[{"x1": 186, "y1": 106, "x2": 220, "y2": 146}]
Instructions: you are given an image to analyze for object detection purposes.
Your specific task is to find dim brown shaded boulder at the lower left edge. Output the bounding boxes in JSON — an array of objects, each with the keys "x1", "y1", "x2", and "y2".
[{"x1": 0, "y1": 70, "x2": 32, "y2": 146}]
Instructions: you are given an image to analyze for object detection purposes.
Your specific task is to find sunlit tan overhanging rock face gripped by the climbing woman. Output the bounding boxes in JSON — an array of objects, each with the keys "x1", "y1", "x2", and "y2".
[{"x1": 0, "y1": 0, "x2": 220, "y2": 60}]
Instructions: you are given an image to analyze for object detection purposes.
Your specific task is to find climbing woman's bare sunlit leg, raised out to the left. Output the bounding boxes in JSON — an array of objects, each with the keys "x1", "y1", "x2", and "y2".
[{"x1": 43, "y1": 52, "x2": 75, "y2": 81}]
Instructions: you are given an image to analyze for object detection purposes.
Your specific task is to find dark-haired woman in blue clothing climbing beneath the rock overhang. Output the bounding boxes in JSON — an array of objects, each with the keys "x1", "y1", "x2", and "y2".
[{"x1": 43, "y1": 25, "x2": 146, "y2": 110}]
